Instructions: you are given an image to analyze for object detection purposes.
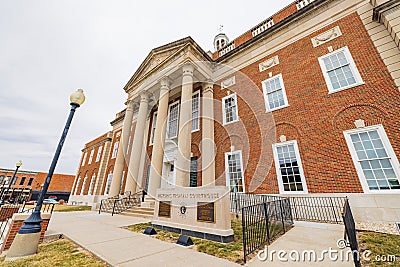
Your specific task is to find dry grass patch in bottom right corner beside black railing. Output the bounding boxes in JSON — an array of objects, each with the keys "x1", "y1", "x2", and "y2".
[{"x1": 358, "y1": 232, "x2": 400, "y2": 267}]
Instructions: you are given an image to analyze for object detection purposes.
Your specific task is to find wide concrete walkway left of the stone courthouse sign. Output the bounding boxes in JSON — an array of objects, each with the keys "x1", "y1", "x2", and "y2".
[{"x1": 46, "y1": 212, "x2": 240, "y2": 267}]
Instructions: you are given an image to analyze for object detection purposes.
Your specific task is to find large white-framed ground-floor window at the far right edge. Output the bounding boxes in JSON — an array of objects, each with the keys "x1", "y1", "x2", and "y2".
[{"x1": 344, "y1": 125, "x2": 400, "y2": 192}]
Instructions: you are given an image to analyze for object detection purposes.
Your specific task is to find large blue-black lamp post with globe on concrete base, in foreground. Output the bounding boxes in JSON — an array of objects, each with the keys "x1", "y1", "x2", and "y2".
[{"x1": 7, "y1": 89, "x2": 85, "y2": 258}]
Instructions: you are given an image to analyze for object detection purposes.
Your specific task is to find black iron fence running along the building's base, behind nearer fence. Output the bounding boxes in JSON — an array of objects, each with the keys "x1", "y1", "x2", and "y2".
[{"x1": 230, "y1": 193, "x2": 346, "y2": 223}]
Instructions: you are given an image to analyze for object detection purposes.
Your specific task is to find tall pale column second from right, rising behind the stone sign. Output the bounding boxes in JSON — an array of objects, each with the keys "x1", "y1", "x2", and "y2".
[{"x1": 176, "y1": 63, "x2": 194, "y2": 187}]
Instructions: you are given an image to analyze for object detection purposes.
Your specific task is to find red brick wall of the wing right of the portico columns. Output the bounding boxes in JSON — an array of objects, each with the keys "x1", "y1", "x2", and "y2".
[{"x1": 214, "y1": 13, "x2": 400, "y2": 193}]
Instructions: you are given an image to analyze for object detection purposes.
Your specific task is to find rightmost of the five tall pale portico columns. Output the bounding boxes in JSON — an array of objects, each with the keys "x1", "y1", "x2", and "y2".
[{"x1": 201, "y1": 82, "x2": 216, "y2": 186}]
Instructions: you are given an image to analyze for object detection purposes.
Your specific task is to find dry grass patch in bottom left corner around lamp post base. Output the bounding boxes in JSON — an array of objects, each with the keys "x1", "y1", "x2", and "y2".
[{"x1": 0, "y1": 239, "x2": 107, "y2": 267}]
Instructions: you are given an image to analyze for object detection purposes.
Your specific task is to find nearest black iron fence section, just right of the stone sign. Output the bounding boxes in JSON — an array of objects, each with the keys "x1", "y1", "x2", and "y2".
[{"x1": 241, "y1": 199, "x2": 293, "y2": 263}]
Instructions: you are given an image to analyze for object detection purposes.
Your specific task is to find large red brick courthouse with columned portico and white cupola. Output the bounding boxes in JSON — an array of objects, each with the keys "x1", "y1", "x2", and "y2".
[{"x1": 70, "y1": 0, "x2": 400, "y2": 225}]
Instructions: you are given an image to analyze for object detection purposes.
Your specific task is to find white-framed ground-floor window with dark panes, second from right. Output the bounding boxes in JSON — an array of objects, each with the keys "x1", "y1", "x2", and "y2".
[{"x1": 272, "y1": 140, "x2": 307, "y2": 193}]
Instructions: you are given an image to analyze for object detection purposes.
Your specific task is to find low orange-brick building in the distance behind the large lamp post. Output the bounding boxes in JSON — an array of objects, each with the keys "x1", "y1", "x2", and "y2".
[{"x1": 0, "y1": 169, "x2": 75, "y2": 201}]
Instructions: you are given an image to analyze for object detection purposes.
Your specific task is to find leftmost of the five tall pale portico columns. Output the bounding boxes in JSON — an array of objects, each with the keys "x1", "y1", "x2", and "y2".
[{"x1": 108, "y1": 101, "x2": 133, "y2": 197}]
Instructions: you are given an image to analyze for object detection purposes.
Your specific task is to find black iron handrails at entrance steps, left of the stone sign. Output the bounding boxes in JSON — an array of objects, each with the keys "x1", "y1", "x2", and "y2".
[{"x1": 99, "y1": 191, "x2": 142, "y2": 216}]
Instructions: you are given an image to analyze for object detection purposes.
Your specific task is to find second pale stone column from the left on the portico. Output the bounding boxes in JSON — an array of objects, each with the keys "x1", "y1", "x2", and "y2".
[{"x1": 125, "y1": 92, "x2": 149, "y2": 194}]
